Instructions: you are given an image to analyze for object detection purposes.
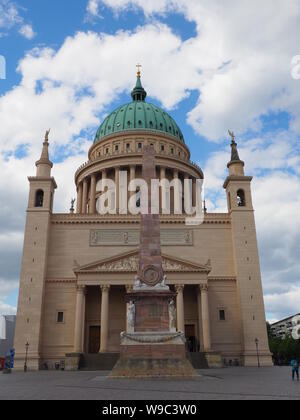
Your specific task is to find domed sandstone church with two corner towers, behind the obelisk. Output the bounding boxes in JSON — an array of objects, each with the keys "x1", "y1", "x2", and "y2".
[{"x1": 15, "y1": 72, "x2": 272, "y2": 370}]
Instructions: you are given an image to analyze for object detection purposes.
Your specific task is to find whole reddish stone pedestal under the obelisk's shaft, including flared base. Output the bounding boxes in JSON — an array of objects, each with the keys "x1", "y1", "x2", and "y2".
[{"x1": 110, "y1": 288, "x2": 197, "y2": 378}]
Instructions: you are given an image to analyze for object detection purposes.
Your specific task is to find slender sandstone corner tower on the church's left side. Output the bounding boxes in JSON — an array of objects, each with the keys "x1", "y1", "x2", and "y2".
[{"x1": 15, "y1": 130, "x2": 56, "y2": 370}]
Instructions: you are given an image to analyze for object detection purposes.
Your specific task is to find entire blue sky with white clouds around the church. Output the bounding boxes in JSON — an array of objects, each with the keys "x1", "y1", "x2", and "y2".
[{"x1": 0, "y1": 0, "x2": 300, "y2": 320}]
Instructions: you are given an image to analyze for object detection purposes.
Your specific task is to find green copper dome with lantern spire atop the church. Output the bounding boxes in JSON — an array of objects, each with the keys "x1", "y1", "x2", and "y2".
[{"x1": 94, "y1": 73, "x2": 184, "y2": 143}]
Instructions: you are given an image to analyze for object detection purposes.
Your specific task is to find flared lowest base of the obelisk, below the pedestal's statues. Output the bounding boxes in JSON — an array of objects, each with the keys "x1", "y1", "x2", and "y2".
[{"x1": 110, "y1": 332, "x2": 198, "y2": 378}]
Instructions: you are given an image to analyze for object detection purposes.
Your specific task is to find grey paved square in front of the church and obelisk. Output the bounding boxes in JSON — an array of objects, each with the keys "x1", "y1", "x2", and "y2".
[{"x1": 0, "y1": 367, "x2": 300, "y2": 401}]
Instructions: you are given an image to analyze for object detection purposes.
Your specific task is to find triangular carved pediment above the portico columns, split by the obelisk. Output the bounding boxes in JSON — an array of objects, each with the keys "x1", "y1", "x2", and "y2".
[{"x1": 74, "y1": 250, "x2": 211, "y2": 274}]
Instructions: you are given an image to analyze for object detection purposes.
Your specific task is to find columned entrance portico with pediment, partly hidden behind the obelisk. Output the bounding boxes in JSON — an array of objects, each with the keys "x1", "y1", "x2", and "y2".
[{"x1": 74, "y1": 250, "x2": 211, "y2": 353}]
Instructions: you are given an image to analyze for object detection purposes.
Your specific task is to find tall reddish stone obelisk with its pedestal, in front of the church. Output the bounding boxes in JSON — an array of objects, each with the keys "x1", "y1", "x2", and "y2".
[{"x1": 110, "y1": 145, "x2": 197, "y2": 378}]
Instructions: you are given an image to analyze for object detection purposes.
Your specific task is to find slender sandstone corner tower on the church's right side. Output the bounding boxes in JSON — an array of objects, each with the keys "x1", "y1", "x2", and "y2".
[{"x1": 224, "y1": 132, "x2": 272, "y2": 366}]
